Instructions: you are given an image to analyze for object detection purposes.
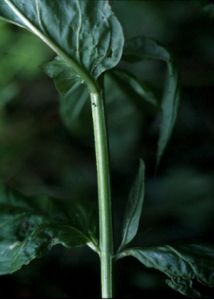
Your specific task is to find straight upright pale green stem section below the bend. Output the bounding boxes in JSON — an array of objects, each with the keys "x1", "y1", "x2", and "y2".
[{"x1": 91, "y1": 93, "x2": 113, "y2": 298}]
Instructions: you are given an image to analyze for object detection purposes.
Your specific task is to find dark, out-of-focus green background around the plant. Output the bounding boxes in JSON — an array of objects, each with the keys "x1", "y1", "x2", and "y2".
[{"x1": 0, "y1": 0, "x2": 214, "y2": 298}]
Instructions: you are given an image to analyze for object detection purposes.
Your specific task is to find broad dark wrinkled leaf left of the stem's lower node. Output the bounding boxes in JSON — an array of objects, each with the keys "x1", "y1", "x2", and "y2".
[{"x1": 0, "y1": 186, "x2": 97, "y2": 275}]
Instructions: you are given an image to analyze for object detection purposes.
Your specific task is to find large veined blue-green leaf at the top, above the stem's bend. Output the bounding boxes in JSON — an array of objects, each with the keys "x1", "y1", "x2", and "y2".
[{"x1": 0, "y1": 0, "x2": 124, "y2": 80}]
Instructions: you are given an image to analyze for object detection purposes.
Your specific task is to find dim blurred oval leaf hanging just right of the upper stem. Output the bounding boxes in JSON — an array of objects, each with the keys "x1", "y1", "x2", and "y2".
[{"x1": 104, "y1": 72, "x2": 142, "y2": 170}]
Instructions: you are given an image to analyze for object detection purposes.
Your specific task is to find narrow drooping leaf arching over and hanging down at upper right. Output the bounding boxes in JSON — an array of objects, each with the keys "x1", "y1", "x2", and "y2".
[{"x1": 124, "y1": 37, "x2": 180, "y2": 166}]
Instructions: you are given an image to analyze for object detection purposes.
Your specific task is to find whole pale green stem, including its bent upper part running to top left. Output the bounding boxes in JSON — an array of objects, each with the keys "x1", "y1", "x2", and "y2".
[{"x1": 3, "y1": 0, "x2": 113, "y2": 298}]
